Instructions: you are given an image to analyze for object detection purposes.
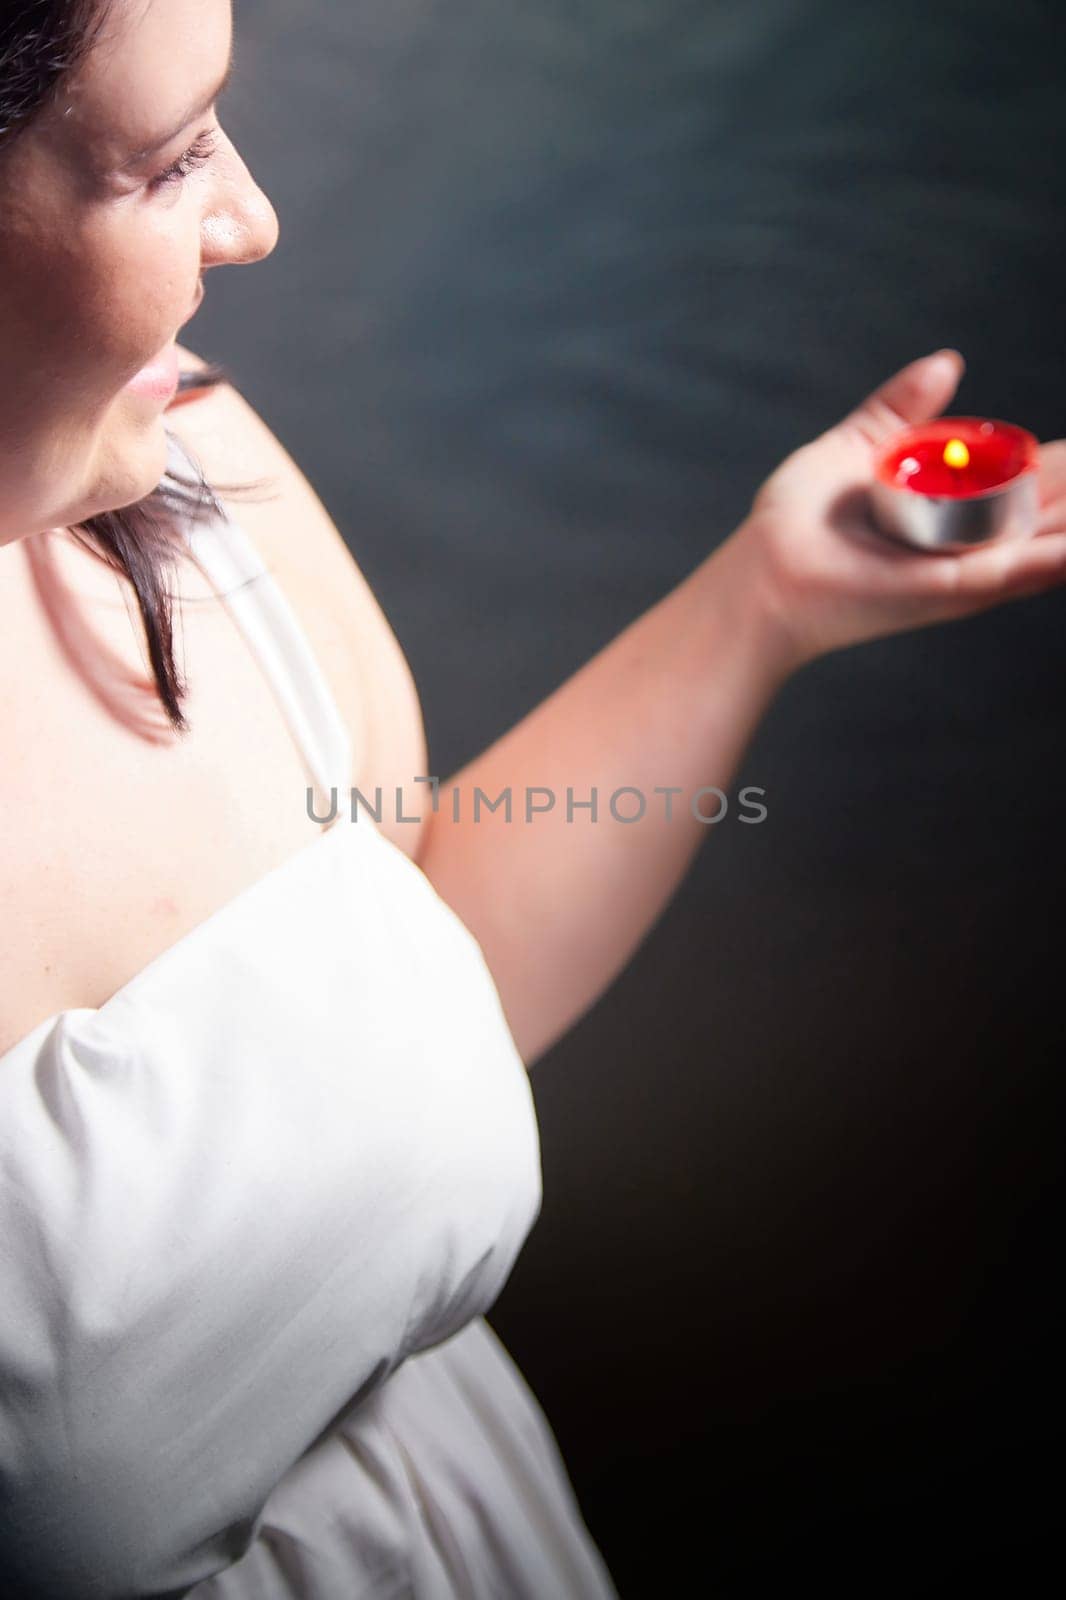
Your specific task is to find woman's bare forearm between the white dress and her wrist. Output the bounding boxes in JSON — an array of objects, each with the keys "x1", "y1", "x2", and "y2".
[{"x1": 418, "y1": 539, "x2": 791, "y2": 1064}]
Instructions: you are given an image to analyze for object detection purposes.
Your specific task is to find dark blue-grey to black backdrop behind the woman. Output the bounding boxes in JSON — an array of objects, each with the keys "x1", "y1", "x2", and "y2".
[{"x1": 201, "y1": 0, "x2": 1066, "y2": 1600}]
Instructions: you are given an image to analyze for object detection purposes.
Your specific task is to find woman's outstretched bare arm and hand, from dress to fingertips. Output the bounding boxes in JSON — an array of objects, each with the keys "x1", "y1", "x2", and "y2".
[{"x1": 416, "y1": 354, "x2": 1066, "y2": 1064}]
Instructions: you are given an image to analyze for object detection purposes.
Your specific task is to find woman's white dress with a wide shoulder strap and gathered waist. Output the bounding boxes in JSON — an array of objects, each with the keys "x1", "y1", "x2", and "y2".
[{"x1": 0, "y1": 440, "x2": 616, "y2": 1600}]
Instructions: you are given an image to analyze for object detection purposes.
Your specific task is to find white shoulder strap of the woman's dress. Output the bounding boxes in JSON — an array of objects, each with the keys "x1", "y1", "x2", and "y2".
[{"x1": 160, "y1": 432, "x2": 352, "y2": 816}]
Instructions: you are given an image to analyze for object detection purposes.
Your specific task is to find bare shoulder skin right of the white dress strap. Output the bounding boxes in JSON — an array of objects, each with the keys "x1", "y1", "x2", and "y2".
[{"x1": 168, "y1": 346, "x2": 427, "y2": 856}]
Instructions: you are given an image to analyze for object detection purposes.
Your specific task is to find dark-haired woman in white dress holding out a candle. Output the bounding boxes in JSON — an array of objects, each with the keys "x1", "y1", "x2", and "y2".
[{"x1": 0, "y1": 0, "x2": 1066, "y2": 1600}]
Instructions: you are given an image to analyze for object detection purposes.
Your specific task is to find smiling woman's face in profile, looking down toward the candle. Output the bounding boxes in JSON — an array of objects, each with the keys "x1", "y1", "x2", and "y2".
[{"x1": 0, "y1": 0, "x2": 277, "y2": 550}]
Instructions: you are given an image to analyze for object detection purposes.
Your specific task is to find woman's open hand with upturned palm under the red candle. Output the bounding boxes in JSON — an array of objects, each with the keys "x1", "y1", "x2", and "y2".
[{"x1": 733, "y1": 350, "x2": 1066, "y2": 667}]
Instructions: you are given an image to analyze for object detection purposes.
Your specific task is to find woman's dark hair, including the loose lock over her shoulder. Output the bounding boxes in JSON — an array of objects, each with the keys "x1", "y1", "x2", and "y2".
[{"x1": 0, "y1": 0, "x2": 273, "y2": 733}]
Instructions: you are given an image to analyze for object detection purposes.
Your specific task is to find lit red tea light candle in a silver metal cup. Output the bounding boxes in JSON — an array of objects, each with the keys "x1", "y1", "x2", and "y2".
[{"x1": 871, "y1": 416, "x2": 1039, "y2": 550}]
